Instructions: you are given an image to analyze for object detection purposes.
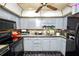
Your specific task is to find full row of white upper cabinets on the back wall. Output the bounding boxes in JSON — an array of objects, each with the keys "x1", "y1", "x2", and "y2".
[{"x1": 20, "y1": 17, "x2": 67, "y2": 29}]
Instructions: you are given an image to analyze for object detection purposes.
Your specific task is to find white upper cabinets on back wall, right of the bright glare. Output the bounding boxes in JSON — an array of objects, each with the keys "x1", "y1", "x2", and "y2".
[{"x1": 41, "y1": 17, "x2": 67, "y2": 29}]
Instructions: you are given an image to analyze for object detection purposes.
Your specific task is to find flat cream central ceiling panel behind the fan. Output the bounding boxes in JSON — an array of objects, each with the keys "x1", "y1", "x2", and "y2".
[{"x1": 18, "y1": 3, "x2": 69, "y2": 11}]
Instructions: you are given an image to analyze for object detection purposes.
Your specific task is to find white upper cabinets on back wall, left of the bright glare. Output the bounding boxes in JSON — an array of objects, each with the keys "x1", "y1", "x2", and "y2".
[{"x1": 20, "y1": 18, "x2": 39, "y2": 29}]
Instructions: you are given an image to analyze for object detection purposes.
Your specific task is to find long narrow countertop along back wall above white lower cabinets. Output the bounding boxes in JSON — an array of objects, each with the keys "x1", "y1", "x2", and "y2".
[{"x1": 21, "y1": 35, "x2": 66, "y2": 39}]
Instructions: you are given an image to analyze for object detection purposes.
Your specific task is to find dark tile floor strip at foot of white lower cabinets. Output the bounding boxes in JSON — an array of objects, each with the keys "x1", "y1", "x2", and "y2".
[{"x1": 24, "y1": 51, "x2": 63, "y2": 56}]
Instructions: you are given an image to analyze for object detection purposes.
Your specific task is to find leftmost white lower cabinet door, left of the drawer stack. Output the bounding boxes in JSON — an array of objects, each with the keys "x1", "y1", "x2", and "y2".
[{"x1": 24, "y1": 38, "x2": 33, "y2": 51}]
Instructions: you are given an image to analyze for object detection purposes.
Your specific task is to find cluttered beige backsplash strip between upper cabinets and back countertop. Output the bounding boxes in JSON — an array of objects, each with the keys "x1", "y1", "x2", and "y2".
[{"x1": 21, "y1": 29, "x2": 67, "y2": 36}]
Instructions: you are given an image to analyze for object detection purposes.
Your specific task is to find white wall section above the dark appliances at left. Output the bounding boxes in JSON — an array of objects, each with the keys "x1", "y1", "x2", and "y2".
[{"x1": 0, "y1": 7, "x2": 20, "y2": 28}]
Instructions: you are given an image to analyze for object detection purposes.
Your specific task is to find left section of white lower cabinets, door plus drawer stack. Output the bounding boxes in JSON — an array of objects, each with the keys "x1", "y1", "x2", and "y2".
[{"x1": 24, "y1": 38, "x2": 42, "y2": 51}]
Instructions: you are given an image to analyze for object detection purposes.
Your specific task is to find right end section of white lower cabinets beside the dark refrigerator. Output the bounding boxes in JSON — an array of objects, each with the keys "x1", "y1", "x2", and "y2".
[{"x1": 50, "y1": 37, "x2": 66, "y2": 55}]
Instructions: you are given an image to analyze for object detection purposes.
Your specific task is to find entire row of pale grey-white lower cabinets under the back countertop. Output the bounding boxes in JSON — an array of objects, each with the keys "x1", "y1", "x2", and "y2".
[{"x1": 24, "y1": 37, "x2": 66, "y2": 55}]
